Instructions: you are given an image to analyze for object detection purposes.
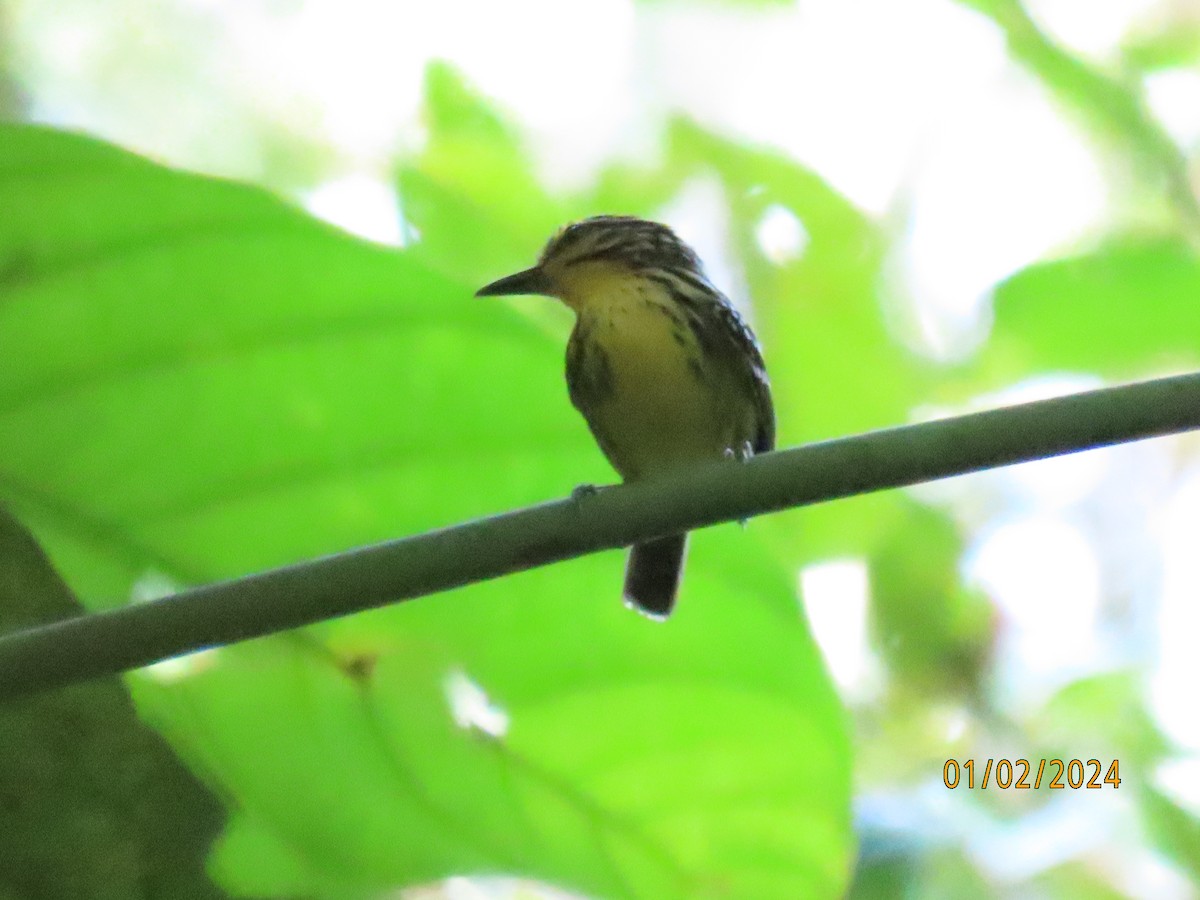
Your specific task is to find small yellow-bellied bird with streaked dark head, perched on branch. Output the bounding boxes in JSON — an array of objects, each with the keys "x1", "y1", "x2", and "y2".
[{"x1": 476, "y1": 216, "x2": 775, "y2": 619}]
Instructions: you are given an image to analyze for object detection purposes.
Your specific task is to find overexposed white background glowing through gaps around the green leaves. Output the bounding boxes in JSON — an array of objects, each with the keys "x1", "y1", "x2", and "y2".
[{"x1": 7, "y1": 0, "x2": 1200, "y2": 896}]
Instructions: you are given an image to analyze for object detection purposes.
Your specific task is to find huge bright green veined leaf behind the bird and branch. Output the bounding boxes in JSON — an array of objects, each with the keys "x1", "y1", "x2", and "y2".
[{"x1": 0, "y1": 127, "x2": 851, "y2": 898}]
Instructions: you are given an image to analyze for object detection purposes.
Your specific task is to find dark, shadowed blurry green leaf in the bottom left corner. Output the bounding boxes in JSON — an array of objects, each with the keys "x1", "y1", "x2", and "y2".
[{"x1": 0, "y1": 509, "x2": 224, "y2": 900}]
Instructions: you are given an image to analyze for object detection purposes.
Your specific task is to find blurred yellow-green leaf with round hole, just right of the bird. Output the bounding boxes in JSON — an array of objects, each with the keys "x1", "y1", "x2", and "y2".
[{"x1": 671, "y1": 114, "x2": 932, "y2": 564}]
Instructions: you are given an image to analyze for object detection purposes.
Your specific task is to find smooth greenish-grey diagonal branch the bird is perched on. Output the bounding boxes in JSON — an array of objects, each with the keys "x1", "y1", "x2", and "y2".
[{"x1": 0, "y1": 372, "x2": 1200, "y2": 700}]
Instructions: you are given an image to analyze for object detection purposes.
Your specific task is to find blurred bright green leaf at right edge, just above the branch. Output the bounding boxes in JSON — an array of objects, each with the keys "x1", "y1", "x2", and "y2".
[{"x1": 983, "y1": 238, "x2": 1200, "y2": 379}]
